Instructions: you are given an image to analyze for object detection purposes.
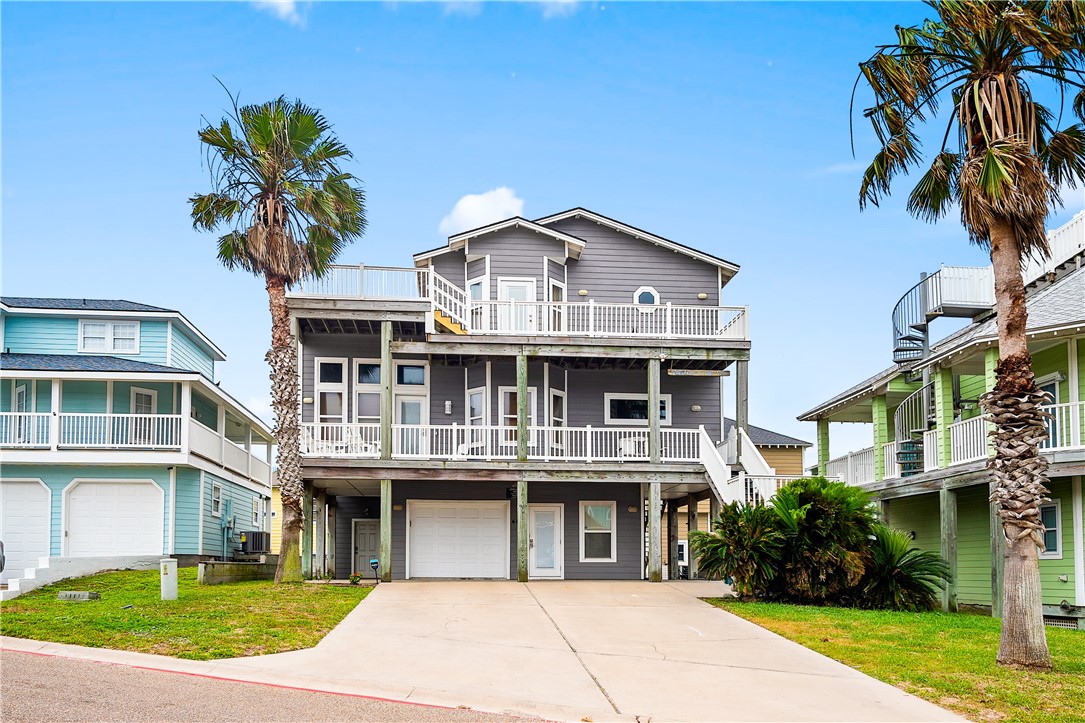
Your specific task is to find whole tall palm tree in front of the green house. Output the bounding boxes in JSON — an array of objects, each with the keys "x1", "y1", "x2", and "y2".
[{"x1": 853, "y1": 0, "x2": 1085, "y2": 668}]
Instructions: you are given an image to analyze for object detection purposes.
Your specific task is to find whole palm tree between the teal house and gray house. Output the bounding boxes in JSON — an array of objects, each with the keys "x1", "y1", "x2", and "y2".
[{"x1": 189, "y1": 97, "x2": 366, "y2": 582}]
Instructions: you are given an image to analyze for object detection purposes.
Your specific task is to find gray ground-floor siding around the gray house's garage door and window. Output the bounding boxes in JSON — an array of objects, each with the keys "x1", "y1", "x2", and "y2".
[{"x1": 381, "y1": 481, "x2": 643, "y2": 580}]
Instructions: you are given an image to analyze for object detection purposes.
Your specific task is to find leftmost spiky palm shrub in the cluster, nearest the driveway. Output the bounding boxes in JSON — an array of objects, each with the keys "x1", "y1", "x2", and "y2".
[{"x1": 689, "y1": 503, "x2": 783, "y2": 596}]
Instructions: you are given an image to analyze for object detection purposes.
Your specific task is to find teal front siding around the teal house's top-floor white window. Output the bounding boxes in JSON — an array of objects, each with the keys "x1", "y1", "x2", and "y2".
[{"x1": 3, "y1": 314, "x2": 168, "y2": 365}]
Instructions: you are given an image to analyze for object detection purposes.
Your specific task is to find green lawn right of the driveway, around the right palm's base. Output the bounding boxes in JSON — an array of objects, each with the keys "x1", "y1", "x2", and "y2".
[{"x1": 709, "y1": 598, "x2": 1085, "y2": 723}]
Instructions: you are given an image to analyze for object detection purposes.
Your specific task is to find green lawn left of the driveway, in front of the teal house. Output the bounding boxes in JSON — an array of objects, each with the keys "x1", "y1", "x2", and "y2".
[{"x1": 0, "y1": 568, "x2": 370, "y2": 660}]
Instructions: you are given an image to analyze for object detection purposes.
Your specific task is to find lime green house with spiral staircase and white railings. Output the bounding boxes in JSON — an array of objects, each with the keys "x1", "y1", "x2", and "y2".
[{"x1": 799, "y1": 211, "x2": 1085, "y2": 630}]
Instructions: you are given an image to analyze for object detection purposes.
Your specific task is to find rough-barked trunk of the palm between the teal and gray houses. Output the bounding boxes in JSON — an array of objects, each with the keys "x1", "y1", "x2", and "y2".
[{"x1": 265, "y1": 275, "x2": 304, "y2": 583}]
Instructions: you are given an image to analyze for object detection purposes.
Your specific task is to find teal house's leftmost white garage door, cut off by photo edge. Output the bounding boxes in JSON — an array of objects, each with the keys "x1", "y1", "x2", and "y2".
[{"x1": 0, "y1": 481, "x2": 49, "y2": 582}]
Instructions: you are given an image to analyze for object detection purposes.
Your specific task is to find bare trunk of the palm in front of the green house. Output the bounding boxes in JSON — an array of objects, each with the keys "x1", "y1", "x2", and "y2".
[{"x1": 982, "y1": 220, "x2": 1051, "y2": 669}]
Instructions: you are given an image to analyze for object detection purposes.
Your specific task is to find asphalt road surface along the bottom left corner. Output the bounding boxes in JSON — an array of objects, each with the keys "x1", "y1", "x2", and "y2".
[{"x1": 0, "y1": 650, "x2": 518, "y2": 723}]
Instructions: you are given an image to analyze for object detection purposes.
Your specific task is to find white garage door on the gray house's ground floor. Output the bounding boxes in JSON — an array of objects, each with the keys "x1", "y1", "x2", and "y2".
[{"x1": 407, "y1": 502, "x2": 509, "y2": 580}]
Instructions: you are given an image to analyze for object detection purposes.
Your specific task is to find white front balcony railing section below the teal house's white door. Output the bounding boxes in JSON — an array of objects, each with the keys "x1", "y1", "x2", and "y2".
[{"x1": 60, "y1": 413, "x2": 181, "y2": 449}]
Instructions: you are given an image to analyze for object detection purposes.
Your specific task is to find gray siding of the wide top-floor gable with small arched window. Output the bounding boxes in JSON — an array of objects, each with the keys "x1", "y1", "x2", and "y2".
[{"x1": 550, "y1": 218, "x2": 719, "y2": 306}]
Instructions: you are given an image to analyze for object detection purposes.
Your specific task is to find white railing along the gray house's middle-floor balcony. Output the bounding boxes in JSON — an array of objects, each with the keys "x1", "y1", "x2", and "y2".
[{"x1": 301, "y1": 422, "x2": 704, "y2": 464}]
